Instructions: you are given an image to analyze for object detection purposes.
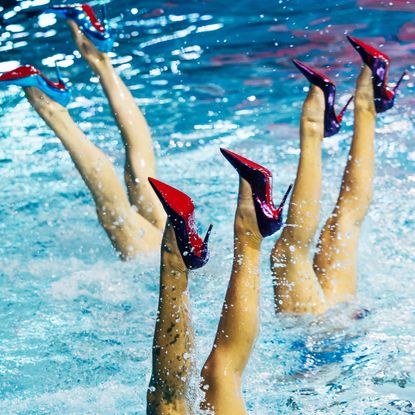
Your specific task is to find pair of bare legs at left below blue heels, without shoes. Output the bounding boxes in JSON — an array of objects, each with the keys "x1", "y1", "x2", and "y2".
[{"x1": 25, "y1": 22, "x2": 165, "y2": 259}]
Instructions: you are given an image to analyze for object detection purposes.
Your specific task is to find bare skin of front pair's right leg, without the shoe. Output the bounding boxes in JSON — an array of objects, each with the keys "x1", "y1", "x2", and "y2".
[{"x1": 202, "y1": 179, "x2": 262, "y2": 415}]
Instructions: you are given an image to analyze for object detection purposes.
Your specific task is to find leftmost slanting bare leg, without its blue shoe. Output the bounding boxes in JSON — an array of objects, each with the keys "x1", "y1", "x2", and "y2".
[{"x1": 25, "y1": 88, "x2": 161, "y2": 259}]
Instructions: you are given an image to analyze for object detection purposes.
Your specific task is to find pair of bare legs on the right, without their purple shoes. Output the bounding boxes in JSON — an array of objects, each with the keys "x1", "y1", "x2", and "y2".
[{"x1": 271, "y1": 65, "x2": 376, "y2": 313}]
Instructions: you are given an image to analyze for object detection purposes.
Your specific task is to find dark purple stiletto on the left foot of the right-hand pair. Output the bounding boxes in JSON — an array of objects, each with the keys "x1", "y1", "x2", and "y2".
[{"x1": 293, "y1": 59, "x2": 353, "y2": 137}]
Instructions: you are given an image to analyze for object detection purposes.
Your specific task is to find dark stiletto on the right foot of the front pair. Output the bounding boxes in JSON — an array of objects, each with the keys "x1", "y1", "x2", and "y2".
[{"x1": 220, "y1": 148, "x2": 292, "y2": 238}]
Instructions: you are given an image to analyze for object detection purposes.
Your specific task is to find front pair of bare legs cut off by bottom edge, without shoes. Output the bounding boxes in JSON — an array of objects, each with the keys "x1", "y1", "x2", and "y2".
[{"x1": 147, "y1": 178, "x2": 263, "y2": 415}]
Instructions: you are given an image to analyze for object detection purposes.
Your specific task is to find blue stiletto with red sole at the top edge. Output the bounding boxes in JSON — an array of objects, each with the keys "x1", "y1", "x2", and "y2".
[{"x1": 43, "y1": 4, "x2": 114, "y2": 53}]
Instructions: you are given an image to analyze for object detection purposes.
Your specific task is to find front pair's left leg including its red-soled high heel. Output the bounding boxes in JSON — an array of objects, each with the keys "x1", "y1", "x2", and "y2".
[{"x1": 147, "y1": 179, "x2": 210, "y2": 415}]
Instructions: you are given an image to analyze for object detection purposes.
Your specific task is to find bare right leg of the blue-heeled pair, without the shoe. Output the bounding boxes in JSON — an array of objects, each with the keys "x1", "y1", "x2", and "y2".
[{"x1": 68, "y1": 21, "x2": 166, "y2": 229}]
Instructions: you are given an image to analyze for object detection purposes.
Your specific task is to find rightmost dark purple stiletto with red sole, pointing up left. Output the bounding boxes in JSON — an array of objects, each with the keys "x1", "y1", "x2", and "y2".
[{"x1": 347, "y1": 36, "x2": 406, "y2": 112}]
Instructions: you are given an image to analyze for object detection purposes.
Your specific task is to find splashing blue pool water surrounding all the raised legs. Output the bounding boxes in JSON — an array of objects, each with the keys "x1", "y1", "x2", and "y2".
[{"x1": 0, "y1": 0, "x2": 415, "y2": 415}]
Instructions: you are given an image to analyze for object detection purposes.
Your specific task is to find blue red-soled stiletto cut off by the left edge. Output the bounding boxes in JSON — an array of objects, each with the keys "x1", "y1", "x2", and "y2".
[{"x1": 0, "y1": 65, "x2": 71, "y2": 107}]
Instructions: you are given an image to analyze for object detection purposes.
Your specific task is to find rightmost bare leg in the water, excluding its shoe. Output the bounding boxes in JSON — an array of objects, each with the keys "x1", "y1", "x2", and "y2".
[{"x1": 314, "y1": 66, "x2": 376, "y2": 303}]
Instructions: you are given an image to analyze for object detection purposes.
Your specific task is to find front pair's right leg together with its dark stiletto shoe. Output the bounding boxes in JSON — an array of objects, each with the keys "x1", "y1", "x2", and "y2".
[{"x1": 202, "y1": 150, "x2": 287, "y2": 415}]
